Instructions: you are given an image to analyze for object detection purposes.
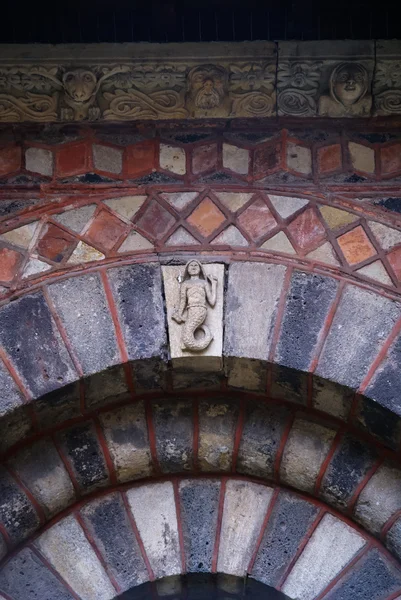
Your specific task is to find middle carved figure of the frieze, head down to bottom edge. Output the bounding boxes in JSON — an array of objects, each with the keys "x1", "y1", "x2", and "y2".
[{"x1": 186, "y1": 65, "x2": 231, "y2": 117}]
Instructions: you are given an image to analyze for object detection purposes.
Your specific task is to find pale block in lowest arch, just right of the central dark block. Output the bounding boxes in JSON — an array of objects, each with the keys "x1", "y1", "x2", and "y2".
[{"x1": 217, "y1": 481, "x2": 273, "y2": 577}]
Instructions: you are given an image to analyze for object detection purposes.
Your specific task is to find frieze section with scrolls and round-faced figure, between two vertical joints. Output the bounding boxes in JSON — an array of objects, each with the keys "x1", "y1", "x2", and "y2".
[{"x1": 277, "y1": 41, "x2": 375, "y2": 118}]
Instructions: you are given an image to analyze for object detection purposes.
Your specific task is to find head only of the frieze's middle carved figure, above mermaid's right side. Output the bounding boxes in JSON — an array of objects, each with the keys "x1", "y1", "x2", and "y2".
[{"x1": 188, "y1": 65, "x2": 227, "y2": 110}]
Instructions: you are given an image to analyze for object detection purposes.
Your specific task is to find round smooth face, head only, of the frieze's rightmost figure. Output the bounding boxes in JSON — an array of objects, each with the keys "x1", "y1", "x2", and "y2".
[{"x1": 330, "y1": 63, "x2": 369, "y2": 106}]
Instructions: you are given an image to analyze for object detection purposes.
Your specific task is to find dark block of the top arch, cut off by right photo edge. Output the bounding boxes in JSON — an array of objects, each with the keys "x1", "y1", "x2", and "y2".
[{"x1": 366, "y1": 337, "x2": 401, "y2": 416}]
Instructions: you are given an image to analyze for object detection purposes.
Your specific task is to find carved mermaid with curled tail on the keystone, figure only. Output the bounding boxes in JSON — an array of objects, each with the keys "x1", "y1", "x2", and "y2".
[{"x1": 172, "y1": 260, "x2": 217, "y2": 352}]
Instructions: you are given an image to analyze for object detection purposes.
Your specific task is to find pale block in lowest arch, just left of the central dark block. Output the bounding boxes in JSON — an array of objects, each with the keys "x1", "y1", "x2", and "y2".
[{"x1": 127, "y1": 481, "x2": 181, "y2": 578}]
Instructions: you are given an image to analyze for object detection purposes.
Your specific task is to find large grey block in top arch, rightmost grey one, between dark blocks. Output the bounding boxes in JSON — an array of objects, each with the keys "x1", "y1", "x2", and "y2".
[{"x1": 316, "y1": 285, "x2": 400, "y2": 388}]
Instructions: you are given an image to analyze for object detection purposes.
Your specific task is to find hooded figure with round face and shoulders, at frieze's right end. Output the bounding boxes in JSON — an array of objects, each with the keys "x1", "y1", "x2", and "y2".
[{"x1": 319, "y1": 63, "x2": 372, "y2": 117}]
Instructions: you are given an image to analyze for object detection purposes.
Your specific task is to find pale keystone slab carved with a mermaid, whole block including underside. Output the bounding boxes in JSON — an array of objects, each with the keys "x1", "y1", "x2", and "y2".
[{"x1": 162, "y1": 259, "x2": 224, "y2": 371}]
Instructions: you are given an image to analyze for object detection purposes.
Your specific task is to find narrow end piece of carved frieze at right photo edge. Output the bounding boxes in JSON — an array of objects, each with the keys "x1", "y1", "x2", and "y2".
[{"x1": 373, "y1": 40, "x2": 401, "y2": 116}]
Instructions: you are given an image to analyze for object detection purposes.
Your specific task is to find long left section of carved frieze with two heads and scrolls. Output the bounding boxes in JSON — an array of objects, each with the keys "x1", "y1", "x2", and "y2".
[{"x1": 0, "y1": 42, "x2": 276, "y2": 122}]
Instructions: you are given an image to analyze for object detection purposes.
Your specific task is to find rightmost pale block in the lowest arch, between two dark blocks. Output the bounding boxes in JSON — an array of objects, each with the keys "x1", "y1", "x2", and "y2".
[{"x1": 282, "y1": 515, "x2": 366, "y2": 600}]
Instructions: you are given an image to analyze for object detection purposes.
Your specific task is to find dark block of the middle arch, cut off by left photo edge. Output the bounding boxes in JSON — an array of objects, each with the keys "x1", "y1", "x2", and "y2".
[{"x1": 0, "y1": 467, "x2": 39, "y2": 544}]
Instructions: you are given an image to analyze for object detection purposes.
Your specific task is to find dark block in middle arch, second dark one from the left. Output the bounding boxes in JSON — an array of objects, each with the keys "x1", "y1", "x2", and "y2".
[{"x1": 58, "y1": 423, "x2": 109, "y2": 493}]
